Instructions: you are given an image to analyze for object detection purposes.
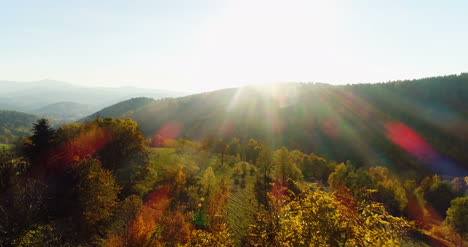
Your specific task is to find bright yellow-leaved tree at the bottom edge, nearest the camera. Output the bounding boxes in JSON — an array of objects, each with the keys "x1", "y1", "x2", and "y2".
[{"x1": 246, "y1": 188, "x2": 413, "y2": 246}]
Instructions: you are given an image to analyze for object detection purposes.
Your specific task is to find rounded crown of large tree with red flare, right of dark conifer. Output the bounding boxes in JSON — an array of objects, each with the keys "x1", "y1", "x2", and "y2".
[{"x1": 50, "y1": 118, "x2": 153, "y2": 192}]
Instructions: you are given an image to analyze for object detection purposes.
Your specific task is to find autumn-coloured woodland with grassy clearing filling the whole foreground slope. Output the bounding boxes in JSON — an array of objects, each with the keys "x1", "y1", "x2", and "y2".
[{"x1": 0, "y1": 118, "x2": 468, "y2": 246}]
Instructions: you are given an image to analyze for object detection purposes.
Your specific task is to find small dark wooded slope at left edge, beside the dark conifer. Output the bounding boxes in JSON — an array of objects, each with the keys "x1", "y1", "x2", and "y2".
[{"x1": 0, "y1": 110, "x2": 37, "y2": 144}]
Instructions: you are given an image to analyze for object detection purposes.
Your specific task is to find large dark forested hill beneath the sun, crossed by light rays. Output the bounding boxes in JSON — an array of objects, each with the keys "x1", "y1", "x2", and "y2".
[{"x1": 83, "y1": 74, "x2": 468, "y2": 175}]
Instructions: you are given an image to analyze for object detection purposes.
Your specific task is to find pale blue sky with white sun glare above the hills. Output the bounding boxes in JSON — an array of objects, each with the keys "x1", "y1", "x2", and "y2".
[{"x1": 0, "y1": 0, "x2": 468, "y2": 92}]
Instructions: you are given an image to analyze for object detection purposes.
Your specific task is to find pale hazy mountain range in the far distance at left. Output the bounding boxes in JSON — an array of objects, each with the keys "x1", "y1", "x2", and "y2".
[{"x1": 0, "y1": 80, "x2": 188, "y2": 120}]
